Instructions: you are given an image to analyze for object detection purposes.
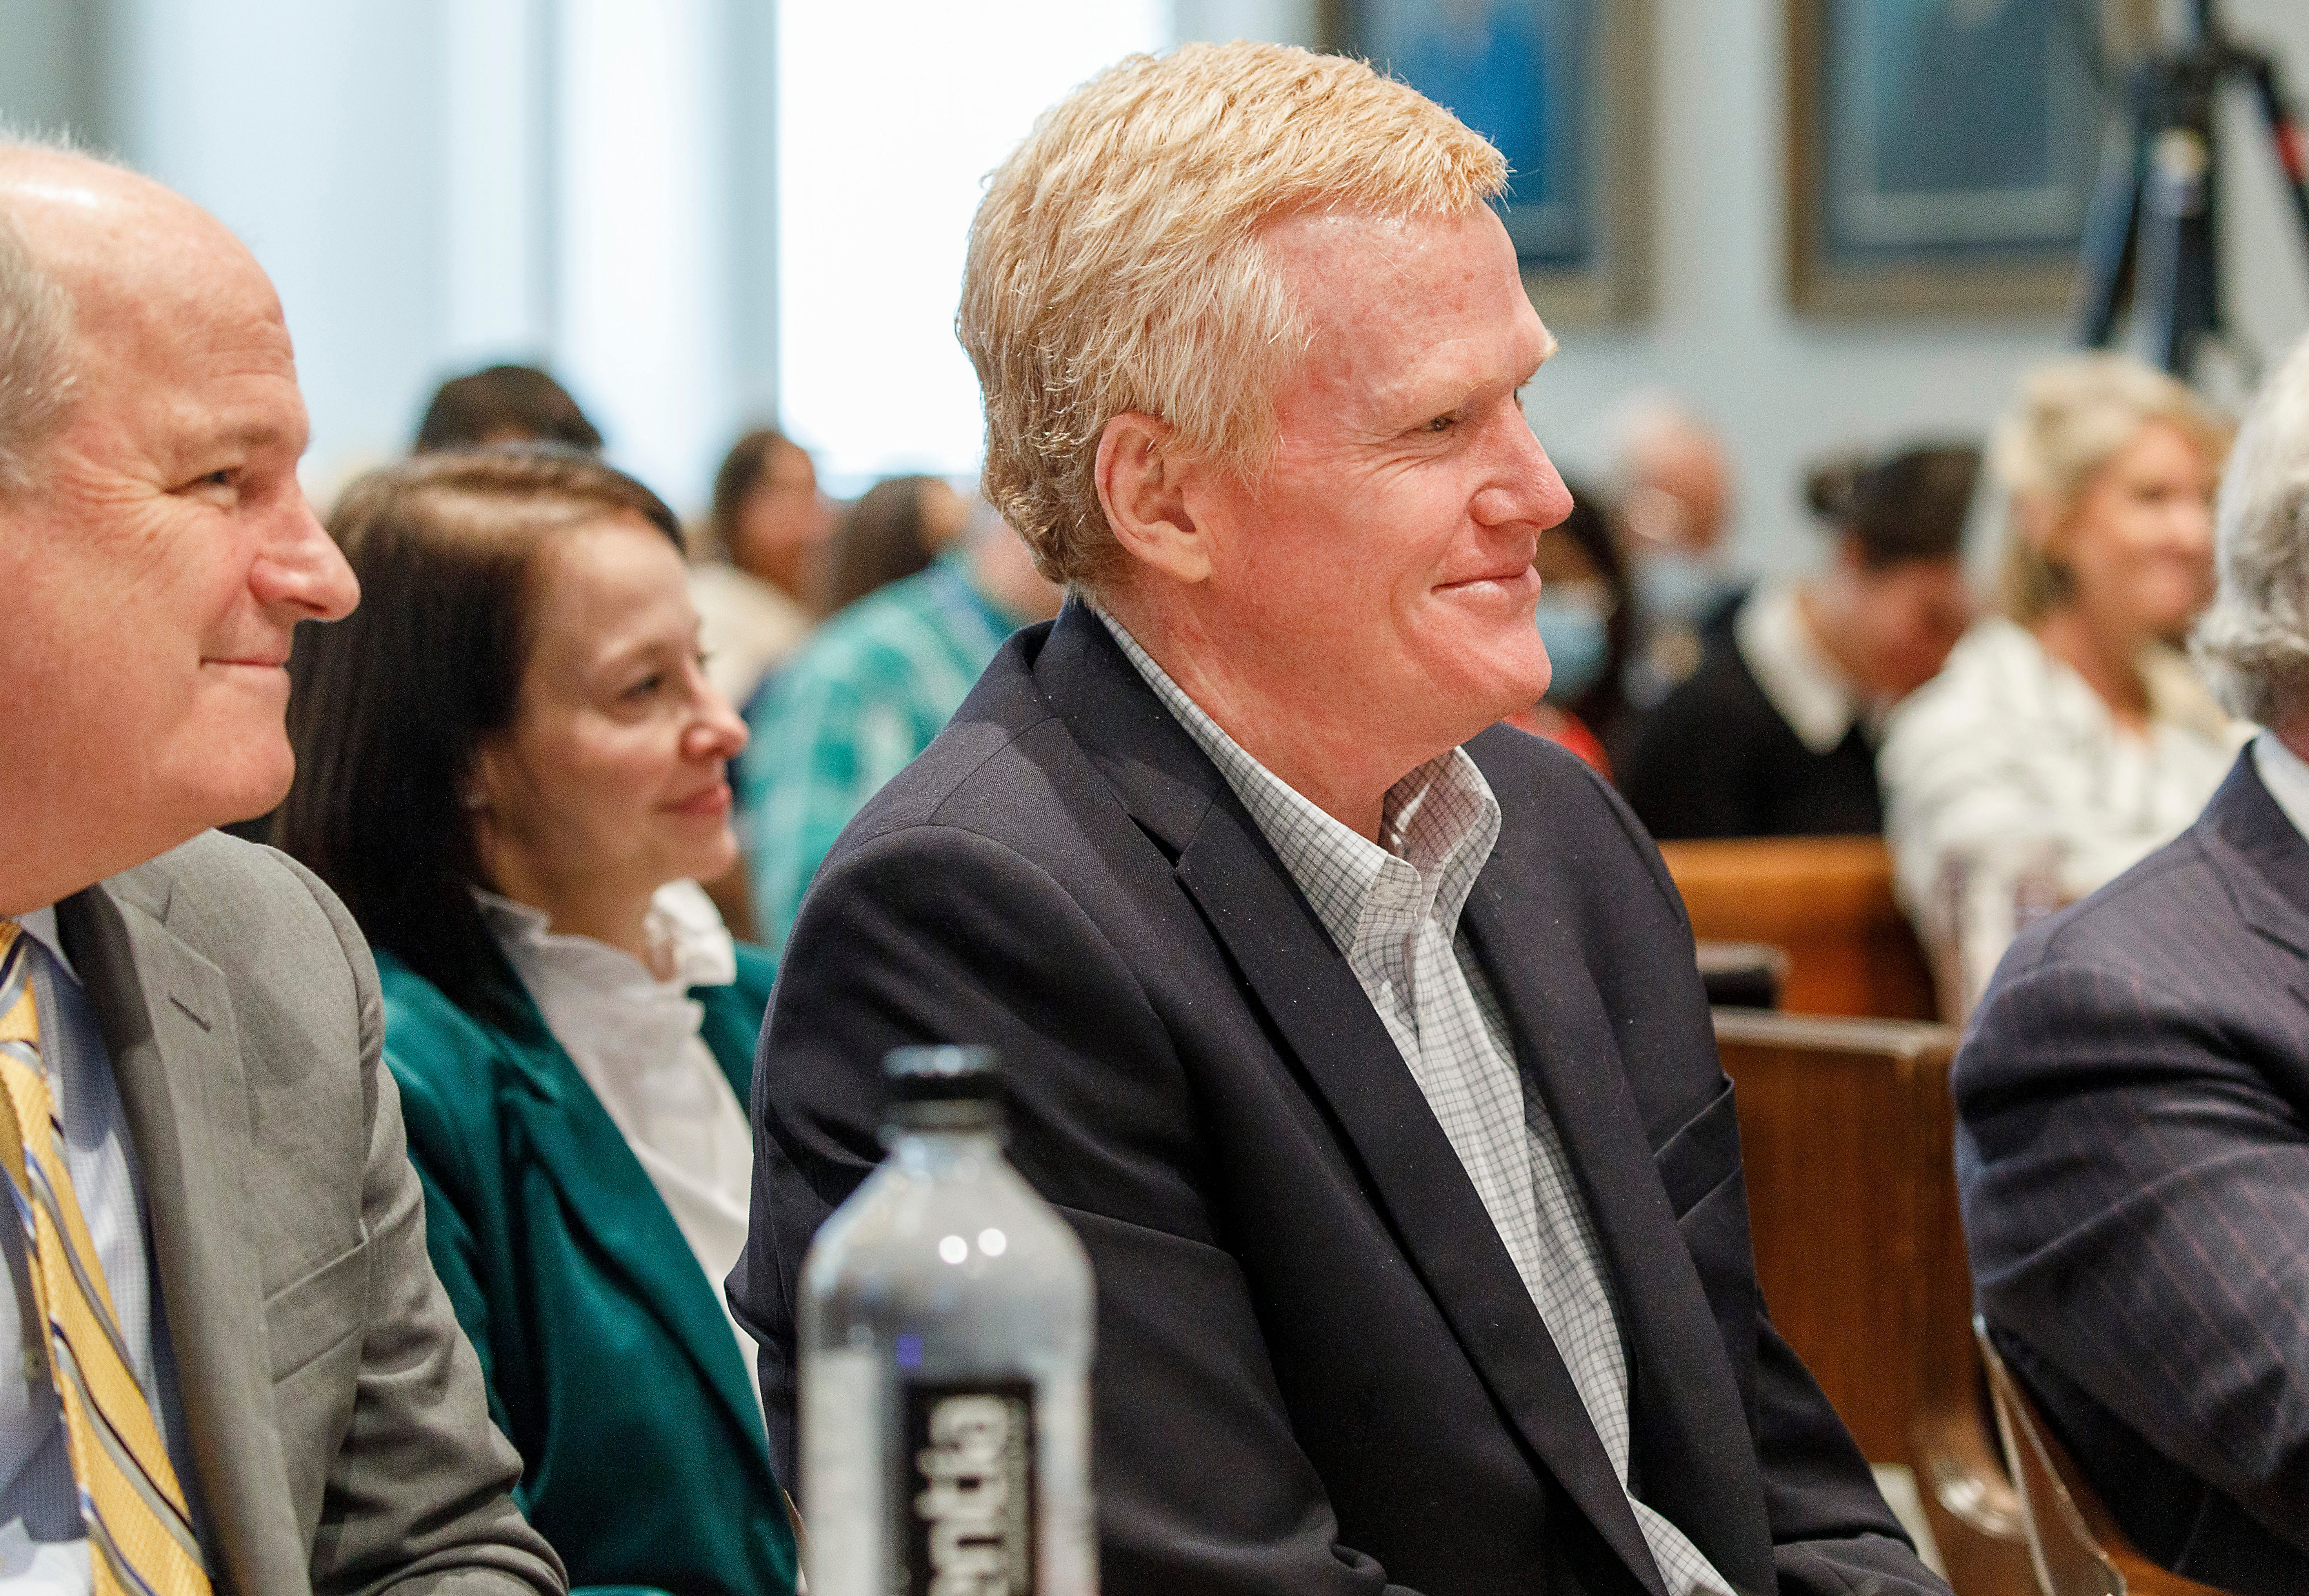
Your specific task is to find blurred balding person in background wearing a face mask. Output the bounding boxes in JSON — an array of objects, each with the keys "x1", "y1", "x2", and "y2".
[{"x1": 1612, "y1": 393, "x2": 1736, "y2": 709}]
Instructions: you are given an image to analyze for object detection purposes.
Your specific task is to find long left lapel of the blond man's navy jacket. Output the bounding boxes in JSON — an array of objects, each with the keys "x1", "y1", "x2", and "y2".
[{"x1": 1035, "y1": 603, "x2": 1671, "y2": 1596}]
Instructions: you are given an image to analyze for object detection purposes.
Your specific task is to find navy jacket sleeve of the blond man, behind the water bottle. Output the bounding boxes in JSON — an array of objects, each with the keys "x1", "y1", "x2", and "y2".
[{"x1": 732, "y1": 827, "x2": 1409, "y2": 1596}]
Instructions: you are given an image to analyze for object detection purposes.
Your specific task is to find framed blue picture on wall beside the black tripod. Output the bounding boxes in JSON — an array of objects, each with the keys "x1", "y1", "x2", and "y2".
[{"x1": 1787, "y1": 0, "x2": 2111, "y2": 316}]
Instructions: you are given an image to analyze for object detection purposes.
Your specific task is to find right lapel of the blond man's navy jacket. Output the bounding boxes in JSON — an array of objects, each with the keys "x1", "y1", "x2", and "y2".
[{"x1": 1464, "y1": 873, "x2": 1776, "y2": 1589}]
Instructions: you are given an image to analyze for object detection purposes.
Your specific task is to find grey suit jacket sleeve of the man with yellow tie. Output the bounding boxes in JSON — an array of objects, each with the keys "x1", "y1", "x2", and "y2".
[{"x1": 269, "y1": 864, "x2": 568, "y2": 1596}]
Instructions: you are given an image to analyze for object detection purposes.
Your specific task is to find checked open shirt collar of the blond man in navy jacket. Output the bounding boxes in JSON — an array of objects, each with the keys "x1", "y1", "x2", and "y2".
[{"x1": 1085, "y1": 601, "x2": 1501, "y2": 954}]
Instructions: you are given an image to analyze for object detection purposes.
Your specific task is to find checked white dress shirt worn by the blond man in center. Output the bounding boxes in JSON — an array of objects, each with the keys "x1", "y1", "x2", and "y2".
[{"x1": 1099, "y1": 612, "x2": 1732, "y2": 1596}]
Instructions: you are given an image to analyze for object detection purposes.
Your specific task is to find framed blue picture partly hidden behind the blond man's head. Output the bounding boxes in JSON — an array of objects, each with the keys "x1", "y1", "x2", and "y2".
[{"x1": 1328, "y1": 0, "x2": 1651, "y2": 323}]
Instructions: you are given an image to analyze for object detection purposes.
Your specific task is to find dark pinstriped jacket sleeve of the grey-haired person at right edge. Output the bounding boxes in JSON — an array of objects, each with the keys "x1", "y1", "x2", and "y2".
[{"x1": 1956, "y1": 940, "x2": 2309, "y2": 1547}]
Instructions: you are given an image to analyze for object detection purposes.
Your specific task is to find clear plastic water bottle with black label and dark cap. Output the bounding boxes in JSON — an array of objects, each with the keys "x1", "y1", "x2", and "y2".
[{"x1": 799, "y1": 1046, "x2": 1099, "y2": 1596}]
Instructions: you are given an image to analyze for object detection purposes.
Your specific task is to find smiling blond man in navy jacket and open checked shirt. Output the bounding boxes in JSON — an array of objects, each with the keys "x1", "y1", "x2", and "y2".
[{"x1": 732, "y1": 46, "x2": 1942, "y2": 1596}]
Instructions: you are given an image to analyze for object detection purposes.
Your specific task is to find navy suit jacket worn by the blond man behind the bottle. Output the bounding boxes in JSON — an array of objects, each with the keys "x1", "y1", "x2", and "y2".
[{"x1": 730, "y1": 605, "x2": 1944, "y2": 1596}]
